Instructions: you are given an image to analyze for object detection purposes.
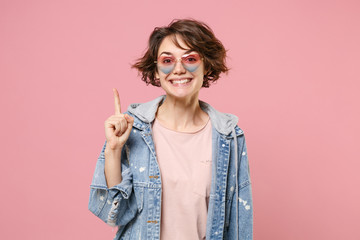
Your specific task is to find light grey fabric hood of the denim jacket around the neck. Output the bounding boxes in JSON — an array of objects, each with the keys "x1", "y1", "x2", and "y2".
[{"x1": 128, "y1": 95, "x2": 243, "y2": 138}]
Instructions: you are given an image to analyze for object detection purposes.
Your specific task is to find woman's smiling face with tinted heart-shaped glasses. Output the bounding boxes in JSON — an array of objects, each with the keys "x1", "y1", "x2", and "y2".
[{"x1": 155, "y1": 36, "x2": 204, "y2": 99}]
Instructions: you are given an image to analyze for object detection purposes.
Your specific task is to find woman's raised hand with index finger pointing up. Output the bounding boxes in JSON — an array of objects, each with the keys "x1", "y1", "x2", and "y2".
[{"x1": 105, "y1": 88, "x2": 134, "y2": 150}]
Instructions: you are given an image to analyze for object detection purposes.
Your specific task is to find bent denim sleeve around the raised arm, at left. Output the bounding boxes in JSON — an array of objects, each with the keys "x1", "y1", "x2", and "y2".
[{"x1": 88, "y1": 141, "x2": 137, "y2": 226}]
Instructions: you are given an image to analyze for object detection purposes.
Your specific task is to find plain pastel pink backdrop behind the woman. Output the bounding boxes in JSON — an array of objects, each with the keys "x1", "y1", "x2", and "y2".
[{"x1": 0, "y1": 0, "x2": 360, "y2": 240}]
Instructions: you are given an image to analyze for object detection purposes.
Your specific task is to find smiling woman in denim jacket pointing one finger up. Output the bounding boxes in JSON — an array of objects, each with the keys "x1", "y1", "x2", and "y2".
[{"x1": 89, "y1": 19, "x2": 253, "y2": 240}]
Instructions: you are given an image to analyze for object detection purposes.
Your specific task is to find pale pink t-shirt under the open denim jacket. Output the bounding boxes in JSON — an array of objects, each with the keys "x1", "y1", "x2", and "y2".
[{"x1": 153, "y1": 119, "x2": 212, "y2": 240}]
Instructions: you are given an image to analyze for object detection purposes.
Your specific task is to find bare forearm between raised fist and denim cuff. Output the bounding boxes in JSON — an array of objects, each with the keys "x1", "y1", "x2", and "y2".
[{"x1": 105, "y1": 146, "x2": 122, "y2": 188}]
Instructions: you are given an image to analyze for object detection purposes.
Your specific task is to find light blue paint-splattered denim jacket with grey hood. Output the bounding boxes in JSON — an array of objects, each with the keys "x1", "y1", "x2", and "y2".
[{"x1": 89, "y1": 96, "x2": 253, "y2": 240}]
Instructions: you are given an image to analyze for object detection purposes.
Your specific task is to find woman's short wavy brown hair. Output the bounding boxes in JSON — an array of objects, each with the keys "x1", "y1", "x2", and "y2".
[{"x1": 131, "y1": 19, "x2": 229, "y2": 88}]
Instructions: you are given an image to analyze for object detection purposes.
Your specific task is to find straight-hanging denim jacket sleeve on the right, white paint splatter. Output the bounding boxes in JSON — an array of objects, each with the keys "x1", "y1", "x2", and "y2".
[{"x1": 229, "y1": 135, "x2": 253, "y2": 240}]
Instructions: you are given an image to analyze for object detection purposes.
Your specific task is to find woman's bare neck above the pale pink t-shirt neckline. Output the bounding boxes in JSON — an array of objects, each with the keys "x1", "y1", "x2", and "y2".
[{"x1": 156, "y1": 95, "x2": 209, "y2": 132}]
